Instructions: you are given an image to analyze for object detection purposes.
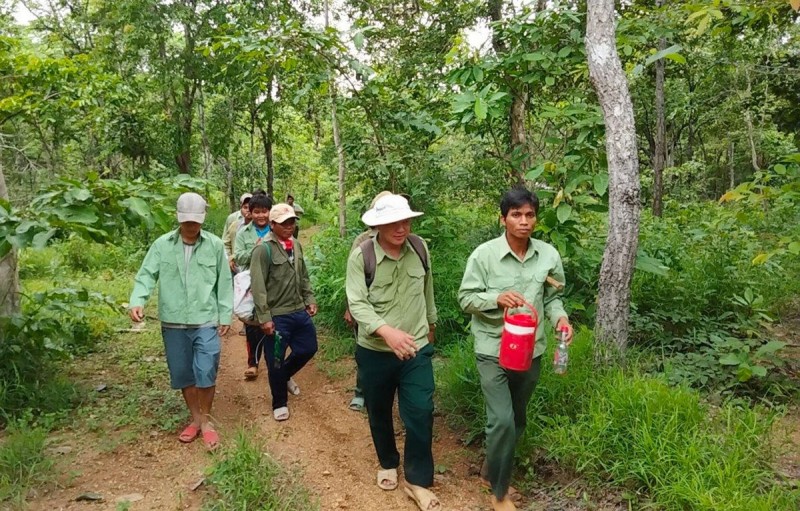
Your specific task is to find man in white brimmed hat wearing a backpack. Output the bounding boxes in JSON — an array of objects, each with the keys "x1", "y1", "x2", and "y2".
[{"x1": 347, "y1": 194, "x2": 441, "y2": 510}]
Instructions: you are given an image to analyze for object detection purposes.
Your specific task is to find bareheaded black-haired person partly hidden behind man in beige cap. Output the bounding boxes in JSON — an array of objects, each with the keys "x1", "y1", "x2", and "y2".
[{"x1": 234, "y1": 194, "x2": 272, "y2": 380}]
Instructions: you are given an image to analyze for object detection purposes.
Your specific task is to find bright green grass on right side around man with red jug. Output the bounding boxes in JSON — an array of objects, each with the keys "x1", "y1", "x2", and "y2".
[{"x1": 437, "y1": 330, "x2": 800, "y2": 511}]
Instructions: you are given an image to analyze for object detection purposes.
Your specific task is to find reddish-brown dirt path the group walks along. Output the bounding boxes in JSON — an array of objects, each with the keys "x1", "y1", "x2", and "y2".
[{"x1": 30, "y1": 231, "x2": 489, "y2": 511}]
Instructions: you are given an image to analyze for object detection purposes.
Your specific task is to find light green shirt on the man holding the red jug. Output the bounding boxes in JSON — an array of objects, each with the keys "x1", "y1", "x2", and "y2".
[{"x1": 458, "y1": 233, "x2": 567, "y2": 357}]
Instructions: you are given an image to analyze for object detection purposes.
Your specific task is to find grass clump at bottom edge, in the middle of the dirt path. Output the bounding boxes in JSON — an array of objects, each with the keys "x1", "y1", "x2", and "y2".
[{"x1": 203, "y1": 429, "x2": 319, "y2": 511}]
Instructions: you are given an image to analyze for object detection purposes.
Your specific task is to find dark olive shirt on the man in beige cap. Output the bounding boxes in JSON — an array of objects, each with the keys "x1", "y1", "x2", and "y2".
[{"x1": 250, "y1": 231, "x2": 317, "y2": 324}]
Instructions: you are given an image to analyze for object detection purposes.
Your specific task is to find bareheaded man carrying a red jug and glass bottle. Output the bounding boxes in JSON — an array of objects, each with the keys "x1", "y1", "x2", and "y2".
[{"x1": 458, "y1": 187, "x2": 572, "y2": 511}]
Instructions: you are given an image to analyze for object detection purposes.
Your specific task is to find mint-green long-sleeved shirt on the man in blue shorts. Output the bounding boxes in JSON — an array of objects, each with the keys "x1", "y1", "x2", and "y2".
[{"x1": 129, "y1": 229, "x2": 233, "y2": 325}]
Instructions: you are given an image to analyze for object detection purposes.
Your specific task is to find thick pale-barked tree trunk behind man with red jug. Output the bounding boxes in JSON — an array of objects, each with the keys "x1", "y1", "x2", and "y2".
[{"x1": 585, "y1": 0, "x2": 641, "y2": 362}]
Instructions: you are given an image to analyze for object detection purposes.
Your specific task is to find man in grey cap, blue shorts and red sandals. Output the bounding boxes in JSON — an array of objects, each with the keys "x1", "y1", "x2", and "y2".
[{"x1": 129, "y1": 193, "x2": 233, "y2": 450}]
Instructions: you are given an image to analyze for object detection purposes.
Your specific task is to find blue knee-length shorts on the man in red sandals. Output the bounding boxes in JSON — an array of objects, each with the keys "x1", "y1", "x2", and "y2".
[{"x1": 161, "y1": 326, "x2": 220, "y2": 389}]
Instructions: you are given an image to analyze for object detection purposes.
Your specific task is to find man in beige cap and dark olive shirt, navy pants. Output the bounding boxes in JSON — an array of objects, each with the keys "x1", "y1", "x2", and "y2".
[{"x1": 250, "y1": 203, "x2": 317, "y2": 421}]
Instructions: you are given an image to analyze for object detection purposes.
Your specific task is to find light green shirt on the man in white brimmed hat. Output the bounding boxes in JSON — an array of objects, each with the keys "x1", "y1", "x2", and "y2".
[{"x1": 346, "y1": 236, "x2": 437, "y2": 352}]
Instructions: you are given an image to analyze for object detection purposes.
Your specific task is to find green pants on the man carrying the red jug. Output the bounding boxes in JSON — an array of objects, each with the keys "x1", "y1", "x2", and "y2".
[{"x1": 476, "y1": 355, "x2": 542, "y2": 499}]
